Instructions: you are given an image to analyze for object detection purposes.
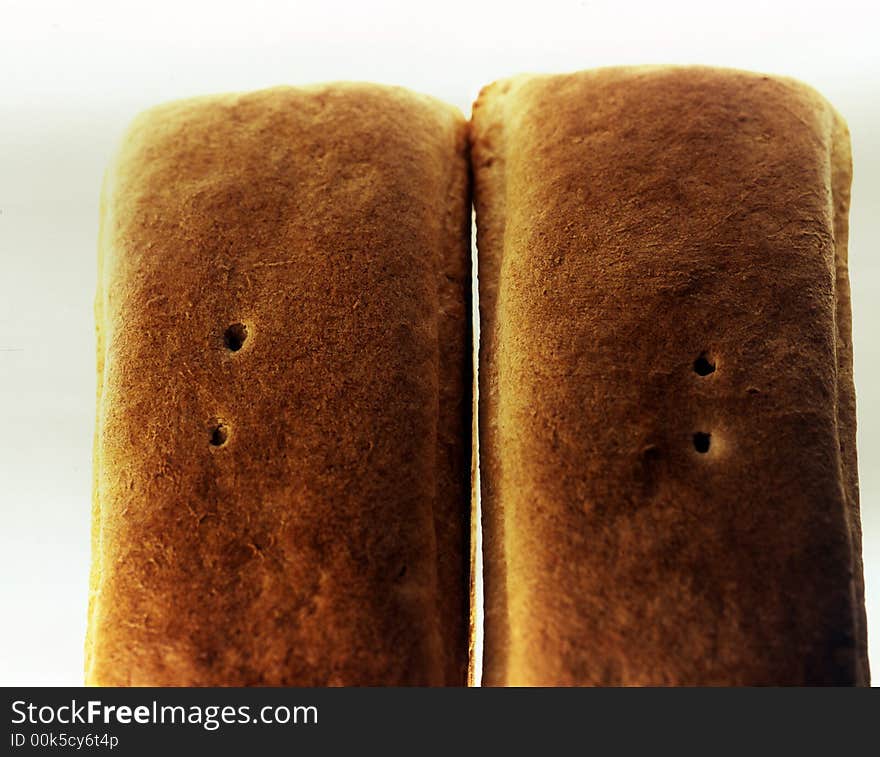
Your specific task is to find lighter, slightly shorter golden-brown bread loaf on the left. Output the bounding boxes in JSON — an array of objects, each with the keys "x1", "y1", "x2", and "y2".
[{"x1": 86, "y1": 84, "x2": 471, "y2": 686}]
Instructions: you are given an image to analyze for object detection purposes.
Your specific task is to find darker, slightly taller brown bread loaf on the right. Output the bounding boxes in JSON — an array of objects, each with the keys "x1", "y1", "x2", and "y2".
[{"x1": 472, "y1": 67, "x2": 868, "y2": 685}]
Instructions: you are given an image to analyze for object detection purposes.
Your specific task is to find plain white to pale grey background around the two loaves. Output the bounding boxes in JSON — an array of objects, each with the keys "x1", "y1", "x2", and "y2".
[{"x1": 0, "y1": 0, "x2": 880, "y2": 685}]
